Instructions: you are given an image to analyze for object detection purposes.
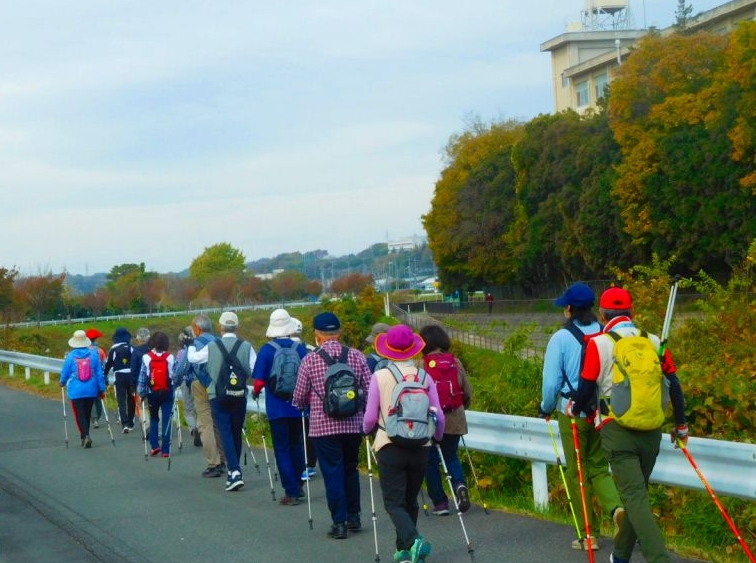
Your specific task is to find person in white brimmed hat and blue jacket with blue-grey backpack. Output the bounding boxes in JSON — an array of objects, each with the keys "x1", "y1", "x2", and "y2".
[{"x1": 252, "y1": 309, "x2": 307, "y2": 506}]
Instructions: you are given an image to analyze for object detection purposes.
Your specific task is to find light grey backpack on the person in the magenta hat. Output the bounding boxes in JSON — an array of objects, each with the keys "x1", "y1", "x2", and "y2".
[{"x1": 383, "y1": 364, "x2": 436, "y2": 447}]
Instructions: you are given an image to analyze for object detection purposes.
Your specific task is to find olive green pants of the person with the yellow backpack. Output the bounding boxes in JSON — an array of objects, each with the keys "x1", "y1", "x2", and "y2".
[{"x1": 601, "y1": 421, "x2": 670, "y2": 563}]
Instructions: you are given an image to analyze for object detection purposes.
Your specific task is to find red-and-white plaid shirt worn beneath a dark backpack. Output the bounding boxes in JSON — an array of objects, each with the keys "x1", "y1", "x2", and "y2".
[{"x1": 291, "y1": 340, "x2": 372, "y2": 438}]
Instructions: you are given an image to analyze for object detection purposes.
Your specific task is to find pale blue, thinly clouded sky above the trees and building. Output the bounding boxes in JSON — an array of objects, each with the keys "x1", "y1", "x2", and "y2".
[{"x1": 0, "y1": 0, "x2": 722, "y2": 275}]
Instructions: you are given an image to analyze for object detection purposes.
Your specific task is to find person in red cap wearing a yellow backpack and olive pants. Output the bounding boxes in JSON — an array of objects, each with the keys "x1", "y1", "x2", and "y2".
[{"x1": 566, "y1": 287, "x2": 688, "y2": 563}]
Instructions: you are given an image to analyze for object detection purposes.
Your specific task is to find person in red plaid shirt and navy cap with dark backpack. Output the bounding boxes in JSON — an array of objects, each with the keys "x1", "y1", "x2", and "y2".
[{"x1": 292, "y1": 312, "x2": 370, "y2": 539}]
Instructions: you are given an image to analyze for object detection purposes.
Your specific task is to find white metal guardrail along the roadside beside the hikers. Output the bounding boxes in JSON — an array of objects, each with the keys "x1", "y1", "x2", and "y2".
[{"x1": 0, "y1": 350, "x2": 756, "y2": 509}]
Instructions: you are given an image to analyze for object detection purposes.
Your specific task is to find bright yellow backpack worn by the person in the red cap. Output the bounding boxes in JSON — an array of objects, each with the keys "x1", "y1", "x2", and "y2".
[{"x1": 608, "y1": 331, "x2": 669, "y2": 430}]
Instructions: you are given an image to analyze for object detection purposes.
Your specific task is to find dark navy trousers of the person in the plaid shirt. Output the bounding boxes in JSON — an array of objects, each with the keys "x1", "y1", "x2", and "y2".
[{"x1": 312, "y1": 434, "x2": 362, "y2": 524}]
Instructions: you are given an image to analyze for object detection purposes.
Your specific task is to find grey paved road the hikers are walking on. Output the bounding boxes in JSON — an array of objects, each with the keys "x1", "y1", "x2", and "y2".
[{"x1": 0, "y1": 386, "x2": 704, "y2": 563}]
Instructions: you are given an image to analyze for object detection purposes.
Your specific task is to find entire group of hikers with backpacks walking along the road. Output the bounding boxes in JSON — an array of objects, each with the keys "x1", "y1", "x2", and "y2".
[{"x1": 60, "y1": 283, "x2": 688, "y2": 563}]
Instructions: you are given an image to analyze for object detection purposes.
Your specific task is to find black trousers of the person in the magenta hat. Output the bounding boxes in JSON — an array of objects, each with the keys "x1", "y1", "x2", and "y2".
[{"x1": 375, "y1": 444, "x2": 430, "y2": 551}]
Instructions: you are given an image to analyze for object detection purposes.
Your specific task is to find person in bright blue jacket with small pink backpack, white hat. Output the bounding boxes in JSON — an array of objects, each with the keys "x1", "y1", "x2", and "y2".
[{"x1": 60, "y1": 330, "x2": 106, "y2": 448}]
